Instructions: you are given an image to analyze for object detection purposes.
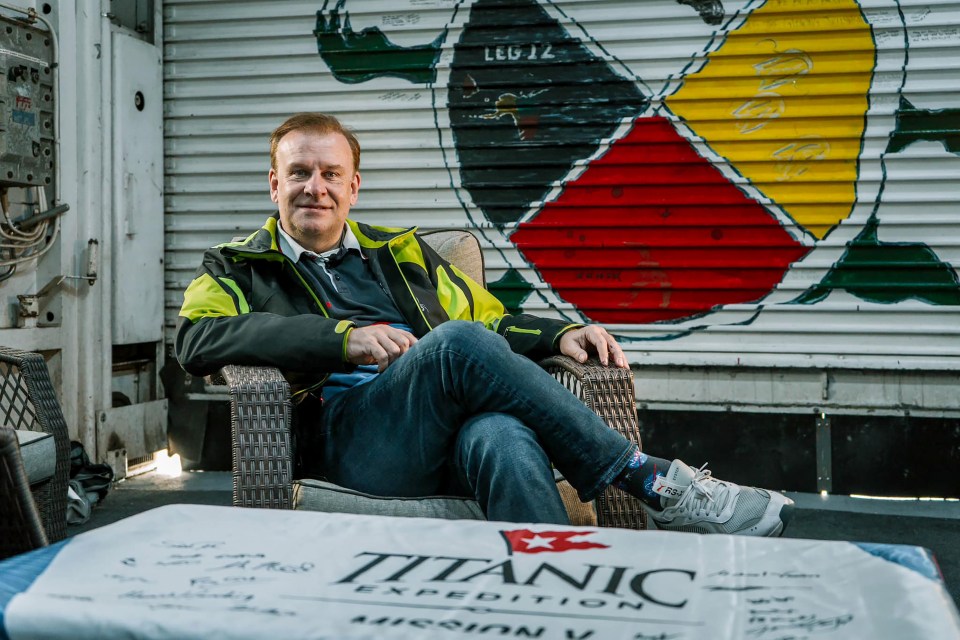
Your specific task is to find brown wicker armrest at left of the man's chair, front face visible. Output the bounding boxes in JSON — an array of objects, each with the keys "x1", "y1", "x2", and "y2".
[{"x1": 220, "y1": 365, "x2": 293, "y2": 509}]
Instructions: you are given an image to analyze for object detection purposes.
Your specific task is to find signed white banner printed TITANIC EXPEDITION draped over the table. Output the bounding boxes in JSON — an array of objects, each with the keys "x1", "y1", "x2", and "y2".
[{"x1": 0, "y1": 505, "x2": 960, "y2": 640}]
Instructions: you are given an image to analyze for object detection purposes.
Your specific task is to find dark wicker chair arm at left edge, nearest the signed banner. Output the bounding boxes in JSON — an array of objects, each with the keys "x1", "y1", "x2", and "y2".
[{"x1": 0, "y1": 427, "x2": 47, "y2": 560}]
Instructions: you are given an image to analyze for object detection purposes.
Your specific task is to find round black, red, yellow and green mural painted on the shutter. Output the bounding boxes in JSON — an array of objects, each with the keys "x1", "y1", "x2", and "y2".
[{"x1": 314, "y1": 0, "x2": 960, "y2": 339}]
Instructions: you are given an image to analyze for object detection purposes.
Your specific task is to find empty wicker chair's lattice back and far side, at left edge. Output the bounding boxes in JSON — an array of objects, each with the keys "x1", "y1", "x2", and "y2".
[{"x1": 0, "y1": 347, "x2": 70, "y2": 542}]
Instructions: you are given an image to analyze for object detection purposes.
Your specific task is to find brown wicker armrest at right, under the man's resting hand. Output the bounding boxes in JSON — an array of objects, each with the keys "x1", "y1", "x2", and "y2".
[{"x1": 540, "y1": 355, "x2": 647, "y2": 529}]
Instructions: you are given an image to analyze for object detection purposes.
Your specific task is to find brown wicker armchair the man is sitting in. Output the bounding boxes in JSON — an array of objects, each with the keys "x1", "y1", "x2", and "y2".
[{"x1": 211, "y1": 231, "x2": 646, "y2": 529}]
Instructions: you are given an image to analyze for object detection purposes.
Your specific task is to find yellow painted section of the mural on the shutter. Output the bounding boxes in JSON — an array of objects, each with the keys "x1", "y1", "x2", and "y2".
[{"x1": 667, "y1": 0, "x2": 874, "y2": 238}]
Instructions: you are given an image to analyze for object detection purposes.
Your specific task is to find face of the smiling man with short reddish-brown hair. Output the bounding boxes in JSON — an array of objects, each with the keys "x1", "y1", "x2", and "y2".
[{"x1": 269, "y1": 130, "x2": 360, "y2": 253}]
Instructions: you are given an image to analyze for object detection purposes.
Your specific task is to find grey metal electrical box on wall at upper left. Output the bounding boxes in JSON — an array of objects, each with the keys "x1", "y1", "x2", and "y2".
[{"x1": 0, "y1": 16, "x2": 54, "y2": 187}]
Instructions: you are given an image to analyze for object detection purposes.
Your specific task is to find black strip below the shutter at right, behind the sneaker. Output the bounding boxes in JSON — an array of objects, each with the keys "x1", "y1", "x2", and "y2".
[{"x1": 638, "y1": 410, "x2": 960, "y2": 498}]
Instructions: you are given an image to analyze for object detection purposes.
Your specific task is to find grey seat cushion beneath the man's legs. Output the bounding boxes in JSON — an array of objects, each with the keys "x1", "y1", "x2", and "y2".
[{"x1": 293, "y1": 479, "x2": 486, "y2": 520}]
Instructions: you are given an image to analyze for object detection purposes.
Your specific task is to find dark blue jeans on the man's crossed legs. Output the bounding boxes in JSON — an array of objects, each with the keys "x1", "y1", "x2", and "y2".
[{"x1": 304, "y1": 321, "x2": 633, "y2": 524}]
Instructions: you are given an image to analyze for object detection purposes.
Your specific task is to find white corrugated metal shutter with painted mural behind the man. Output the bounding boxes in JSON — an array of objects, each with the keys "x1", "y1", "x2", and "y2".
[{"x1": 164, "y1": 0, "x2": 960, "y2": 371}]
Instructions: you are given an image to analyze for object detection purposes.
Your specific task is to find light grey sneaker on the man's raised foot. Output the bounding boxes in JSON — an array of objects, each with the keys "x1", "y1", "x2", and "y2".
[{"x1": 647, "y1": 460, "x2": 793, "y2": 537}]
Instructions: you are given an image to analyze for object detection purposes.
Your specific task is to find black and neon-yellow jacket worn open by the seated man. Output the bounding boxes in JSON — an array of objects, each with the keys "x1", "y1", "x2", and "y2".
[{"x1": 175, "y1": 214, "x2": 580, "y2": 396}]
